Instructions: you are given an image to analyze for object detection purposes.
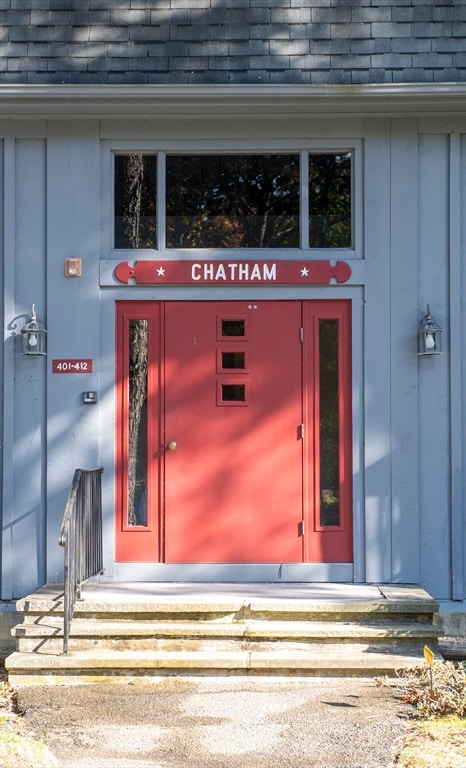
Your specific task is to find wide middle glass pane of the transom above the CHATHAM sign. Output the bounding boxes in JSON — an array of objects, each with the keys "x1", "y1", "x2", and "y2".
[{"x1": 166, "y1": 154, "x2": 300, "y2": 248}]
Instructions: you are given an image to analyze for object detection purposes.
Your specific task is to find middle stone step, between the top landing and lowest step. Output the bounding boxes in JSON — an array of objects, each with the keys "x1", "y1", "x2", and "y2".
[{"x1": 12, "y1": 616, "x2": 438, "y2": 653}]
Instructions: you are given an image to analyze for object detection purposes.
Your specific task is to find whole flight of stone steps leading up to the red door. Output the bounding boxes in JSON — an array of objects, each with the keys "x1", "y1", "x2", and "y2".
[{"x1": 6, "y1": 583, "x2": 439, "y2": 685}]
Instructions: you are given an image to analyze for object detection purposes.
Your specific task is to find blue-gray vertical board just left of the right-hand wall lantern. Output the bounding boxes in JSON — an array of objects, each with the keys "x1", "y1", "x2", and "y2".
[{"x1": 390, "y1": 118, "x2": 420, "y2": 584}]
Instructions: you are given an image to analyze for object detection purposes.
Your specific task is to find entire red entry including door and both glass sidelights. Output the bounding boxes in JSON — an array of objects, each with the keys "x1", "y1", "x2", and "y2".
[{"x1": 116, "y1": 300, "x2": 352, "y2": 564}]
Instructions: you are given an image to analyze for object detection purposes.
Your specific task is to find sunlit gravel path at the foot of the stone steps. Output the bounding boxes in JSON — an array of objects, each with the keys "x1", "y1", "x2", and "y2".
[{"x1": 13, "y1": 678, "x2": 409, "y2": 768}]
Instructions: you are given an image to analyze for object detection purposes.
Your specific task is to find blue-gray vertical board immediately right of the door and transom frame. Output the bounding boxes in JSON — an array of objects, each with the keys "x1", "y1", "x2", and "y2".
[{"x1": 361, "y1": 119, "x2": 392, "y2": 584}]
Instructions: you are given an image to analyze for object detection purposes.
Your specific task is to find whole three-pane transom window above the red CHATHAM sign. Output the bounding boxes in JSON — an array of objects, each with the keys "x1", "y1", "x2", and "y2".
[{"x1": 114, "y1": 150, "x2": 354, "y2": 249}]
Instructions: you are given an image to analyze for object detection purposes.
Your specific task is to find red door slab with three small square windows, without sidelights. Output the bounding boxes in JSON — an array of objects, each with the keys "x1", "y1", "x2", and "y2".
[{"x1": 165, "y1": 301, "x2": 303, "y2": 563}]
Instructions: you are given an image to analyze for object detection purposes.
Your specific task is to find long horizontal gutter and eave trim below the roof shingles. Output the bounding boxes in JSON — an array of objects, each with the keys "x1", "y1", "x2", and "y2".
[{"x1": 0, "y1": 83, "x2": 466, "y2": 120}]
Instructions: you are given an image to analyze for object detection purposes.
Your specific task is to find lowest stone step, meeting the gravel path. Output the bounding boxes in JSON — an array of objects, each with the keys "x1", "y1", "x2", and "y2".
[{"x1": 8, "y1": 650, "x2": 432, "y2": 686}]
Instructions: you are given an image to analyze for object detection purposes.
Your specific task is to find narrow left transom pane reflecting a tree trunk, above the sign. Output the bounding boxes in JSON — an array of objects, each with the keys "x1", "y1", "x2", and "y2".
[{"x1": 115, "y1": 153, "x2": 157, "y2": 248}]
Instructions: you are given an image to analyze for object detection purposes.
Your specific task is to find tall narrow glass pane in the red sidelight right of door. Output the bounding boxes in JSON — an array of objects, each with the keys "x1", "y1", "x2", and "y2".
[{"x1": 319, "y1": 320, "x2": 340, "y2": 526}]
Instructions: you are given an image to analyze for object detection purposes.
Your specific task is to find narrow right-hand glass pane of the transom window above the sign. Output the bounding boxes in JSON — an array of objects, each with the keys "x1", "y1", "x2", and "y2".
[{"x1": 309, "y1": 153, "x2": 352, "y2": 248}]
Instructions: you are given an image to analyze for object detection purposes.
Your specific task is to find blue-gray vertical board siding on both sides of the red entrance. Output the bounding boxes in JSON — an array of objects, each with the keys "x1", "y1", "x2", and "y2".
[{"x1": 2, "y1": 117, "x2": 466, "y2": 600}]
